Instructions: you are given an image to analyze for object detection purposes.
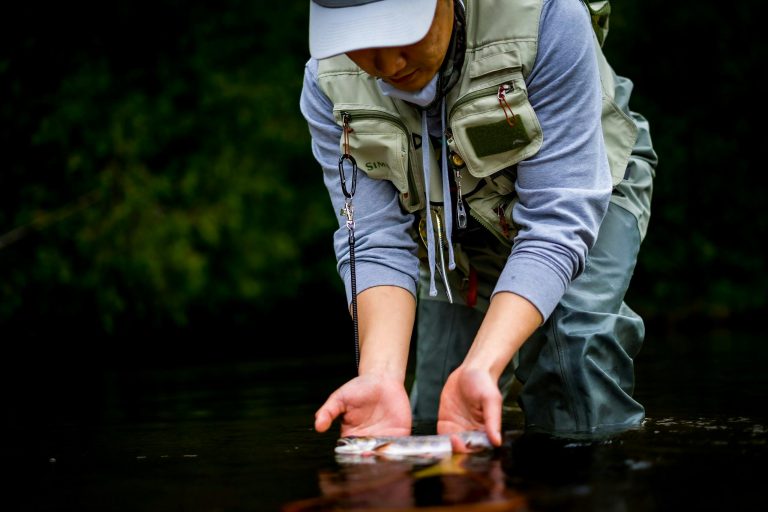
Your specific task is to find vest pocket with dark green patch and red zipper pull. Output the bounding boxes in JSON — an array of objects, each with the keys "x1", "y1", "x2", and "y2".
[{"x1": 449, "y1": 76, "x2": 543, "y2": 177}]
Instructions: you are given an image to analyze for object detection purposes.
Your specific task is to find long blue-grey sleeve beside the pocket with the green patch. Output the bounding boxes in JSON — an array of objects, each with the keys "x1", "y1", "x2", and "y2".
[{"x1": 494, "y1": 0, "x2": 612, "y2": 319}]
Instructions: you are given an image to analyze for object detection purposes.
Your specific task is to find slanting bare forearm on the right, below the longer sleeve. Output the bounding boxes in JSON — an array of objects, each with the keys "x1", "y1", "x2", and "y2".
[{"x1": 462, "y1": 292, "x2": 543, "y2": 379}]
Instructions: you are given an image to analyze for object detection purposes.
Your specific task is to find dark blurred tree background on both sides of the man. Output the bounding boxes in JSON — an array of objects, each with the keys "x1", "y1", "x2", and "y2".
[{"x1": 0, "y1": 0, "x2": 768, "y2": 348}]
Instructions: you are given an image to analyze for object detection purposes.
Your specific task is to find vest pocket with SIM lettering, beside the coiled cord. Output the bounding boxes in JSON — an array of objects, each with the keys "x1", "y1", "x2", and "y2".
[{"x1": 334, "y1": 106, "x2": 424, "y2": 212}]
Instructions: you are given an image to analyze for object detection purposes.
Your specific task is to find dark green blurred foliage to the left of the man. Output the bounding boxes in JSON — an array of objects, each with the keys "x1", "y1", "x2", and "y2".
[{"x1": 0, "y1": 1, "x2": 343, "y2": 333}]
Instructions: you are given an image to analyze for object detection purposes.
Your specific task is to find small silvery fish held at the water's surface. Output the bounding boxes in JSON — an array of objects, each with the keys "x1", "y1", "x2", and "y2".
[{"x1": 335, "y1": 430, "x2": 493, "y2": 458}]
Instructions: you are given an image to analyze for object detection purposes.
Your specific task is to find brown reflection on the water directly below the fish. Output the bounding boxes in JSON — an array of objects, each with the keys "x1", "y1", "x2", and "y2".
[{"x1": 282, "y1": 454, "x2": 527, "y2": 512}]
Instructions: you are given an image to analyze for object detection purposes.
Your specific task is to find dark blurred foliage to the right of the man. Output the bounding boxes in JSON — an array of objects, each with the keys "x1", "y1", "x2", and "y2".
[{"x1": 605, "y1": 0, "x2": 768, "y2": 320}]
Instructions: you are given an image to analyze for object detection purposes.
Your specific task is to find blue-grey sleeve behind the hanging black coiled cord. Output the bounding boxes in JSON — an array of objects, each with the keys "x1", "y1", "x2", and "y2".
[{"x1": 299, "y1": 59, "x2": 419, "y2": 303}]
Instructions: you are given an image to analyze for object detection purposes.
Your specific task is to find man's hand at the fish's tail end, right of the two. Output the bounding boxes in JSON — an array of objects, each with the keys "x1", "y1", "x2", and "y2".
[{"x1": 437, "y1": 366, "x2": 502, "y2": 450}]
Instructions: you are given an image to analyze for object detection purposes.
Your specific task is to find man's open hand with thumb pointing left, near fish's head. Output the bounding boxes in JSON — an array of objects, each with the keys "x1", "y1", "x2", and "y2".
[{"x1": 315, "y1": 374, "x2": 411, "y2": 437}]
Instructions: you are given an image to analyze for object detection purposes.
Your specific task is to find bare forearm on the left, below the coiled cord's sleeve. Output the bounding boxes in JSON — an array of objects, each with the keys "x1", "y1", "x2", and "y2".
[{"x1": 357, "y1": 286, "x2": 416, "y2": 381}]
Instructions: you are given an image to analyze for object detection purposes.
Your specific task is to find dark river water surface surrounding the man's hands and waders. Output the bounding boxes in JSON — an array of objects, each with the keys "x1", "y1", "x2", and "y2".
[{"x1": 4, "y1": 326, "x2": 768, "y2": 512}]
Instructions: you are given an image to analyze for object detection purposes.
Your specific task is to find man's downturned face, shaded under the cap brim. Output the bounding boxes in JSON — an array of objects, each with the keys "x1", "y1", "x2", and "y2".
[{"x1": 347, "y1": 0, "x2": 453, "y2": 91}]
